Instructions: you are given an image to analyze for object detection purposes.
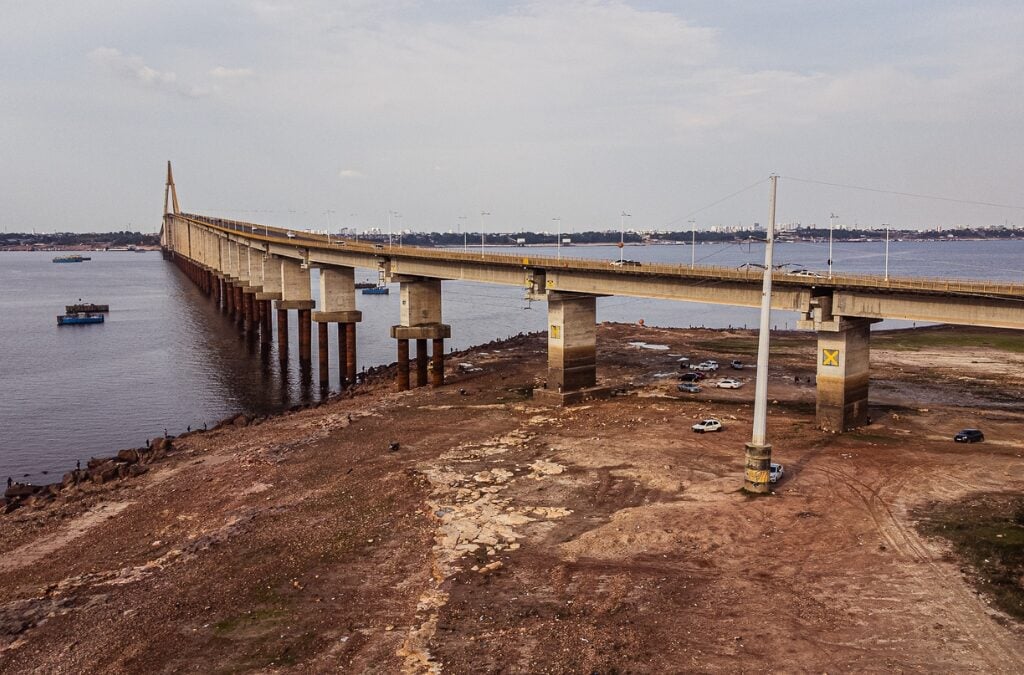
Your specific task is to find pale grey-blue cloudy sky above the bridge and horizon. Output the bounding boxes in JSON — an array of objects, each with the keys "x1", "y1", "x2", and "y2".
[{"x1": 0, "y1": 0, "x2": 1024, "y2": 233}]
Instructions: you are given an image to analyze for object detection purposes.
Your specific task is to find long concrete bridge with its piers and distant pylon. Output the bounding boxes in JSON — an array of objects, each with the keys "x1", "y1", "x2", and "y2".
[{"x1": 161, "y1": 165, "x2": 1024, "y2": 432}]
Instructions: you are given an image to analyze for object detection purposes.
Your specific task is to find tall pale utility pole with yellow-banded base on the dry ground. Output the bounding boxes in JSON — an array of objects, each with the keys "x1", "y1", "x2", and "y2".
[{"x1": 743, "y1": 175, "x2": 778, "y2": 494}]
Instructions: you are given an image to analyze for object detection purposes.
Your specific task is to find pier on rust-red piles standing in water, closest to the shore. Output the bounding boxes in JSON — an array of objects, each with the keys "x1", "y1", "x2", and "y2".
[{"x1": 312, "y1": 266, "x2": 362, "y2": 386}]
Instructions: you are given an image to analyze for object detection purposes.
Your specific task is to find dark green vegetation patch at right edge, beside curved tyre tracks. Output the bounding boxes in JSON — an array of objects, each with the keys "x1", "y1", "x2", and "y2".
[{"x1": 914, "y1": 493, "x2": 1024, "y2": 621}]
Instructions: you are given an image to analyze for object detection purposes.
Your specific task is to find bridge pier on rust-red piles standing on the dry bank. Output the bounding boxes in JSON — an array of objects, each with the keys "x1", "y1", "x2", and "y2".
[{"x1": 391, "y1": 277, "x2": 452, "y2": 391}]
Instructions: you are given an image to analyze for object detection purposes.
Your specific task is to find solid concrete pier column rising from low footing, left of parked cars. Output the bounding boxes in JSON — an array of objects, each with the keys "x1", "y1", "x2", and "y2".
[{"x1": 548, "y1": 293, "x2": 597, "y2": 393}]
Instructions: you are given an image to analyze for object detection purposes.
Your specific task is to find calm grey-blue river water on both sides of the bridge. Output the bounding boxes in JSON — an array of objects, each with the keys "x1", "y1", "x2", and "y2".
[{"x1": 0, "y1": 241, "x2": 1024, "y2": 480}]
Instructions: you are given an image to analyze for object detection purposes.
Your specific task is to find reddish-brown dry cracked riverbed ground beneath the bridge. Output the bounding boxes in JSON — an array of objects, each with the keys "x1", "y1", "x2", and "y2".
[{"x1": 0, "y1": 326, "x2": 1024, "y2": 673}]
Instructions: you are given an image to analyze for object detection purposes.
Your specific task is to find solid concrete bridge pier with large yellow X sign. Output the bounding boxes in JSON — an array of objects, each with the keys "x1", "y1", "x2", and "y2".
[{"x1": 798, "y1": 296, "x2": 880, "y2": 433}]
